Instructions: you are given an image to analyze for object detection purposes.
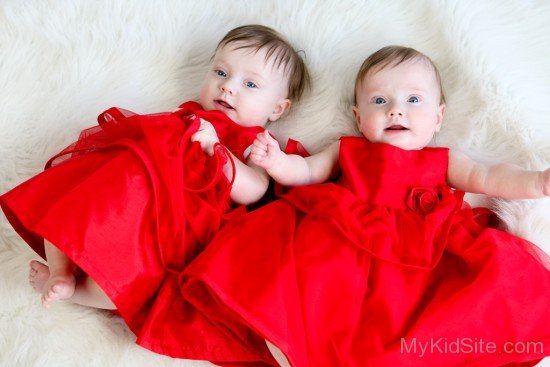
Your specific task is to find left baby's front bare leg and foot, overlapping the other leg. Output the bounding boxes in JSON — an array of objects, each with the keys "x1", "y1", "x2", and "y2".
[{"x1": 42, "y1": 240, "x2": 76, "y2": 308}]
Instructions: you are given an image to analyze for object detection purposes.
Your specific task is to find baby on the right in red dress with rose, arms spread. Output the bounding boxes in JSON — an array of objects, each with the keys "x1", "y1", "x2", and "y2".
[{"x1": 180, "y1": 46, "x2": 550, "y2": 367}]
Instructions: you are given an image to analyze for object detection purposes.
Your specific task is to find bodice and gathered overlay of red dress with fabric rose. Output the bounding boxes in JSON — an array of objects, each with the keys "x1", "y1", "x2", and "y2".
[{"x1": 284, "y1": 137, "x2": 463, "y2": 268}]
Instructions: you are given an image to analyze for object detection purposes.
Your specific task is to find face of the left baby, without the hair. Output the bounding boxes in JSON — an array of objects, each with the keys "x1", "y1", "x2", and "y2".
[{"x1": 199, "y1": 42, "x2": 290, "y2": 126}]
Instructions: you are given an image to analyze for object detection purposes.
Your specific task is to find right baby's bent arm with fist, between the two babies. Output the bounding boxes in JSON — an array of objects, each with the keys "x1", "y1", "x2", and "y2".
[{"x1": 250, "y1": 131, "x2": 340, "y2": 186}]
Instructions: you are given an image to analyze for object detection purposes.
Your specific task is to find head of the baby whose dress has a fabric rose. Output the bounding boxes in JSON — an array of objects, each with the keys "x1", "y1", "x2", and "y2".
[{"x1": 353, "y1": 46, "x2": 445, "y2": 150}]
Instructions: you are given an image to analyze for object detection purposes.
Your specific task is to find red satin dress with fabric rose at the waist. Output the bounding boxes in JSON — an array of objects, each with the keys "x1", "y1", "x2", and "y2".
[{"x1": 180, "y1": 137, "x2": 550, "y2": 367}]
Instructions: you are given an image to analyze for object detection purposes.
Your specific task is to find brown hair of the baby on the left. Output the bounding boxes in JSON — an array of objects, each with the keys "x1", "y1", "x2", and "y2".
[{"x1": 216, "y1": 24, "x2": 311, "y2": 101}]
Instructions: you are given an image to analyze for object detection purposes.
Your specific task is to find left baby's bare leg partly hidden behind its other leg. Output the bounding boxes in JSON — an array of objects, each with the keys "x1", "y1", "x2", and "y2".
[{"x1": 29, "y1": 260, "x2": 116, "y2": 310}]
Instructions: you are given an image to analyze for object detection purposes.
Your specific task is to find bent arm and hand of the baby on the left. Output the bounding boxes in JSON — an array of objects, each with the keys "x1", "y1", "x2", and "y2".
[{"x1": 191, "y1": 119, "x2": 269, "y2": 205}]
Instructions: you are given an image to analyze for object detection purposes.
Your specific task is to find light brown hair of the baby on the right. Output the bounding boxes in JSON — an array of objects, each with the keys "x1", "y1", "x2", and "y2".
[{"x1": 353, "y1": 46, "x2": 445, "y2": 105}]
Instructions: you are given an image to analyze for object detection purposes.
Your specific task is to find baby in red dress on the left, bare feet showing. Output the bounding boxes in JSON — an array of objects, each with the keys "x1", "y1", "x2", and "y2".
[{"x1": 0, "y1": 25, "x2": 309, "y2": 362}]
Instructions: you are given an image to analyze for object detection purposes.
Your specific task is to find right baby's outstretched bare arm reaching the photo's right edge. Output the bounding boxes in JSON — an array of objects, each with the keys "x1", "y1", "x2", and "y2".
[{"x1": 447, "y1": 152, "x2": 550, "y2": 199}]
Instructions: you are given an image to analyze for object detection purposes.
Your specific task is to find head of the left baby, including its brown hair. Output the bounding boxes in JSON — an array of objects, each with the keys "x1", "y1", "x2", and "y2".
[{"x1": 199, "y1": 25, "x2": 310, "y2": 126}]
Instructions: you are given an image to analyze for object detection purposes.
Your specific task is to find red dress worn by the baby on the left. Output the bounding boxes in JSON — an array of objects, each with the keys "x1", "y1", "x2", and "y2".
[{"x1": 0, "y1": 102, "x2": 280, "y2": 365}]
